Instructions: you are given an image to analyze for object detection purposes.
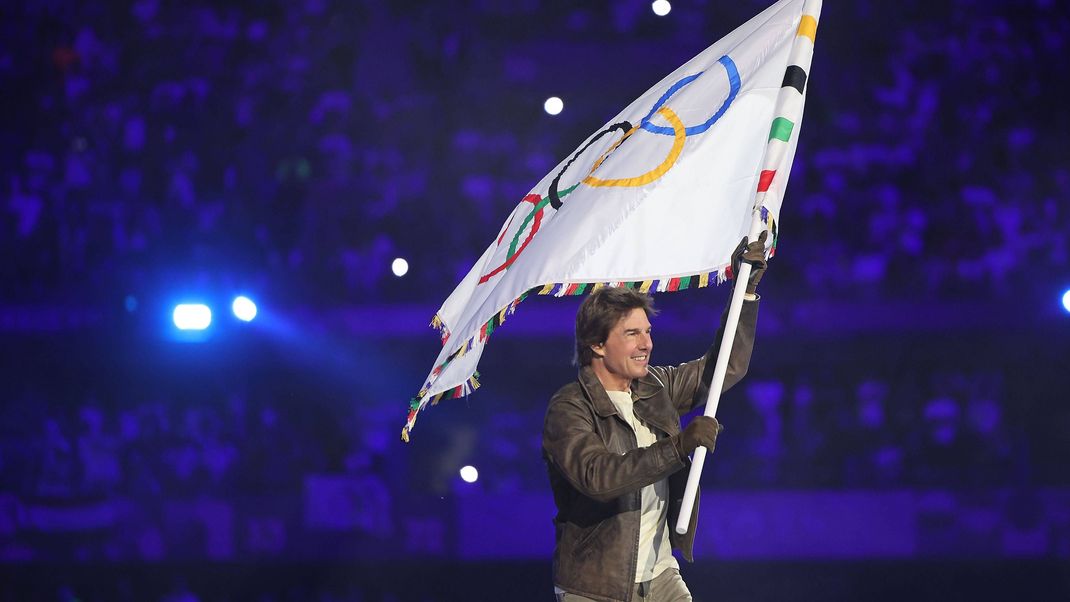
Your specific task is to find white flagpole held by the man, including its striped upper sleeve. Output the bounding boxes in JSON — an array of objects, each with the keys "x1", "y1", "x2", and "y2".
[{"x1": 676, "y1": 0, "x2": 822, "y2": 535}]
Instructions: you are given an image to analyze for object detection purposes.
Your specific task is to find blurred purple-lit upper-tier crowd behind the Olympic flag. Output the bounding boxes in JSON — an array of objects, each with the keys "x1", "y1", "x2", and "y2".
[{"x1": 0, "y1": 0, "x2": 1070, "y2": 304}]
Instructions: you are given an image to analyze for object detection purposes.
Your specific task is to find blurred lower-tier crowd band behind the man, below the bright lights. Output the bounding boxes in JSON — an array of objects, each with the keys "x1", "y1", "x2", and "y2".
[{"x1": 0, "y1": 358, "x2": 1070, "y2": 513}]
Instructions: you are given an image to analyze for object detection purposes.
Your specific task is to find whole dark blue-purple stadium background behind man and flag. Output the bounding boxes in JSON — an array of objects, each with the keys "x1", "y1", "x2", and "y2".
[{"x1": 0, "y1": 0, "x2": 1070, "y2": 602}]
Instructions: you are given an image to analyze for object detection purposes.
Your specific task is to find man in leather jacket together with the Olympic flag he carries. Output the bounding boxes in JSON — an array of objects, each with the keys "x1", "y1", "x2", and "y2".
[{"x1": 401, "y1": 0, "x2": 821, "y2": 601}]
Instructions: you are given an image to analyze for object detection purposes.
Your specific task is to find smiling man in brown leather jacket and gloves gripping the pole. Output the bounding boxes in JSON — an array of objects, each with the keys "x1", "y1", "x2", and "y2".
[{"x1": 542, "y1": 232, "x2": 766, "y2": 602}]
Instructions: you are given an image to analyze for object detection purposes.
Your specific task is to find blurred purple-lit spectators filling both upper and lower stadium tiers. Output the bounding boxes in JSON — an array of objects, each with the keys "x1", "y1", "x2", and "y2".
[{"x1": 0, "y1": 0, "x2": 1070, "y2": 601}]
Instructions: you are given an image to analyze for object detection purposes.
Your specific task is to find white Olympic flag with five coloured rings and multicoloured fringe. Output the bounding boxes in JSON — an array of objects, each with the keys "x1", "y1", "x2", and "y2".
[{"x1": 401, "y1": 0, "x2": 820, "y2": 441}]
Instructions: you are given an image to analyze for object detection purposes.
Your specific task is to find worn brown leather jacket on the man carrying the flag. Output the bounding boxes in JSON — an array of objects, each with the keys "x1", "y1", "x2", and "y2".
[{"x1": 542, "y1": 302, "x2": 758, "y2": 602}]
